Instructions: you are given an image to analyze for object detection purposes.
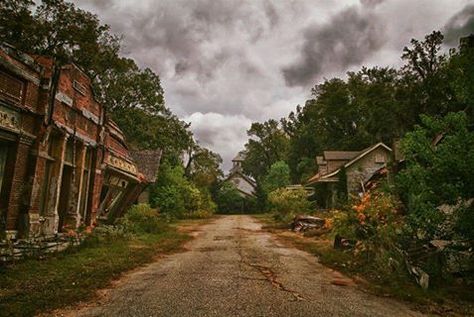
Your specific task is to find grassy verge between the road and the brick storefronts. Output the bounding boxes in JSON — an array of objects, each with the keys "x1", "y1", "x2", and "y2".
[{"x1": 0, "y1": 221, "x2": 191, "y2": 316}]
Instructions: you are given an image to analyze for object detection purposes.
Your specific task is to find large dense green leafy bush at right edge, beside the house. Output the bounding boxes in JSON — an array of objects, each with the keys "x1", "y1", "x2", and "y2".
[{"x1": 397, "y1": 113, "x2": 474, "y2": 239}]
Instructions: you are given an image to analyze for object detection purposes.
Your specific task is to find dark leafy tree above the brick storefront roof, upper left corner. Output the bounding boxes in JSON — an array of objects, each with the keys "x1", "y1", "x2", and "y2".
[{"x1": 0, "y1": 0, "x2": 120, "y2": 77}]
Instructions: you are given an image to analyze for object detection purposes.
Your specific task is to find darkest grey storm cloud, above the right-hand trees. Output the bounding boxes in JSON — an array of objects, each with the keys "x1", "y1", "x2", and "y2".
[{"x1": 283, "y1": 7, "x2": 385, "y2": 86}]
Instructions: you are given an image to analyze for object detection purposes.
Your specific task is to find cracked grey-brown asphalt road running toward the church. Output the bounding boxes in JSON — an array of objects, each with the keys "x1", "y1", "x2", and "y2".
[{"x1": 72, "y1": 216, "x2": 421, "y2": 316}]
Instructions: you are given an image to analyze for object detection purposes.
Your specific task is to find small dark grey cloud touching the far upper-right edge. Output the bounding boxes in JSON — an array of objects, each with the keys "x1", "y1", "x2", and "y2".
[{"x1": 444, "y1": 4, "x2": 474, "y2": 45}]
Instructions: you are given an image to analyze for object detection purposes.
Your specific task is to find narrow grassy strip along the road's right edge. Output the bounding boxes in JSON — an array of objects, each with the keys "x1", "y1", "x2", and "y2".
[{"x1": 255, "y1": 214, "x2": 474, "y2": 315}]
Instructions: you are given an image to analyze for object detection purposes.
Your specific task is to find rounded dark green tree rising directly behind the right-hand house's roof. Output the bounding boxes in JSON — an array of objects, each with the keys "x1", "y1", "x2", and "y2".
[{"x1": 282, "y1": 78, "x2": 370, "y2": 182}]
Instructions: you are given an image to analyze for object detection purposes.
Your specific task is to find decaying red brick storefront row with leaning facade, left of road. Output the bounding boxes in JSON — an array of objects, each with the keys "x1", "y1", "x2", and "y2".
[{"x1": 0, "y1": 44, "x2": 154, "y2": 239}]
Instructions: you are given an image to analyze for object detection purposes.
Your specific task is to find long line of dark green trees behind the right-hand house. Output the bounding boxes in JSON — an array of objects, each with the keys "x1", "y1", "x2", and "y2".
[{"x1": 243, "y1": 31, "x2": 474, "y2": 183}]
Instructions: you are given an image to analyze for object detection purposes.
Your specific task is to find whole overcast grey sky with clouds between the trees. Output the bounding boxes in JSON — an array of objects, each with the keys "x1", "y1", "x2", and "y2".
[{"x1": 74, "y1": 0, "x2": 474, "y2": 168}]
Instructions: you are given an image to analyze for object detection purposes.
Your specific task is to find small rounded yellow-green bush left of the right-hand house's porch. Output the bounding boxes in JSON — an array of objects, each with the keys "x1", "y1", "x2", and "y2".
[{"x1": 268, "y1": 188, "x2": 312, "y2": 222}]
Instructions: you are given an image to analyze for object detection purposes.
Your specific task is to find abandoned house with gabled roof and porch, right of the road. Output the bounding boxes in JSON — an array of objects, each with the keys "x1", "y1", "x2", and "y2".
[{"x1": 306, "y1": 143, "x2": 392, "y2": 208}]
